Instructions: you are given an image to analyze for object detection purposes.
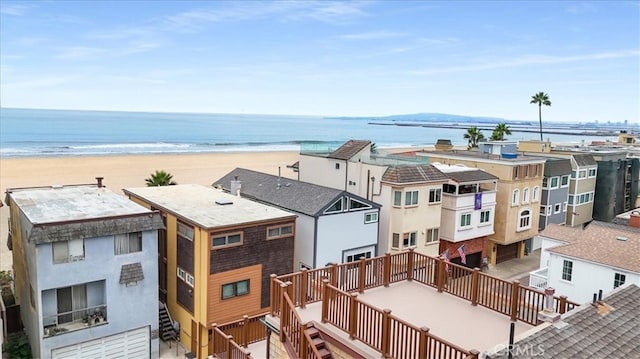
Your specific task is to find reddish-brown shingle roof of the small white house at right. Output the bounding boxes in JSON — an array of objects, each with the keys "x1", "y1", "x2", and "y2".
[{"x1": 541, "y1": 221, "x2": 640, "y2": 273}]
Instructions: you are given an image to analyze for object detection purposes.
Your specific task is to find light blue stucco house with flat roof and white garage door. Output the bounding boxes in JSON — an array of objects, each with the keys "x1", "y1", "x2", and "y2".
[{"x1": 6, "y1": 178, "x2": 163, "y2": 358}]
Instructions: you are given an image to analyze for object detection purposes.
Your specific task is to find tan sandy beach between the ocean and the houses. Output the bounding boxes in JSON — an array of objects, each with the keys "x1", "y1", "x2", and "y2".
[{"x1": 0, "y1": 152, "x2": 299, "y2": 270}]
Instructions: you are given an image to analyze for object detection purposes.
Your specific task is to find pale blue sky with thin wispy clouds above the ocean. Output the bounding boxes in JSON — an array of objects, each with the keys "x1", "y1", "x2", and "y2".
[{"x1": 0, "y1": 0, "x2": 640, "y2": 122}]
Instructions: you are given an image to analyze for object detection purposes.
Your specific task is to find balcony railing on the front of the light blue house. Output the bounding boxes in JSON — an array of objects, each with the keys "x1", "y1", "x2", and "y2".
[{"x1": 42, "y1": 305, "x2": 108, "y2": 338}]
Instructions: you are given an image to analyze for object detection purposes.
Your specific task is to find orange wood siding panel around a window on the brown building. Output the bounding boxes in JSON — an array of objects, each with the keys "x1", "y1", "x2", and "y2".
[{"x1": 207, "y1": 264, "x2": 262, "y2": 325}]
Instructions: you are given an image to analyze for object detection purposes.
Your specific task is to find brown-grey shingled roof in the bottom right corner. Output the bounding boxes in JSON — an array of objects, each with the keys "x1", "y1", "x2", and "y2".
[{"x1": 489, "y1": 284, "x2": 640, "y2": 359}]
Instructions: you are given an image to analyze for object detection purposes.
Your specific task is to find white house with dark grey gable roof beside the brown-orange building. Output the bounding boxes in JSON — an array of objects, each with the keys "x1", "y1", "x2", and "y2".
[{"x1": 213, "y1": 168, "x2": 380, "y2": 269}]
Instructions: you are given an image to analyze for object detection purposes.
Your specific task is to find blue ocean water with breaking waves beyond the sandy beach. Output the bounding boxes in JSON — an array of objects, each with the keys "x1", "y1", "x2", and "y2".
[{"x1": 0, "y1": 108, "x2": 603, "y2": 158}]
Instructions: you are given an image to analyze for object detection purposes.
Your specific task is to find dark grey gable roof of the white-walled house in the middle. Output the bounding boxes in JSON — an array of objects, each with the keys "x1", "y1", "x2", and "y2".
[{"x1": 213, "y1": 168, "x2": 380, "y2": 217}]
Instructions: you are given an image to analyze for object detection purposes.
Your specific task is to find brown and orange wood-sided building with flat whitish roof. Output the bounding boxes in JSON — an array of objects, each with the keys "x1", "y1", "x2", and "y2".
[{"x1": 123, "y1": 184, "x2": 296, "y2": 358}]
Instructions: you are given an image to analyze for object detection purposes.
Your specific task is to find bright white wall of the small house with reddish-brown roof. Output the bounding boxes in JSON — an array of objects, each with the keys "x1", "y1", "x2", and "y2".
[{"x1": 548, "y1": 253, "x2": 640, "y2": 303}]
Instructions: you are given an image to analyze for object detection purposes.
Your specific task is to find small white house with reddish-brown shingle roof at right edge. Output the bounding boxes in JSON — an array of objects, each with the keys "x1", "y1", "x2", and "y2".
[{"x1": 529, "y1": 219, "x2": 640, "y2": 302}]
